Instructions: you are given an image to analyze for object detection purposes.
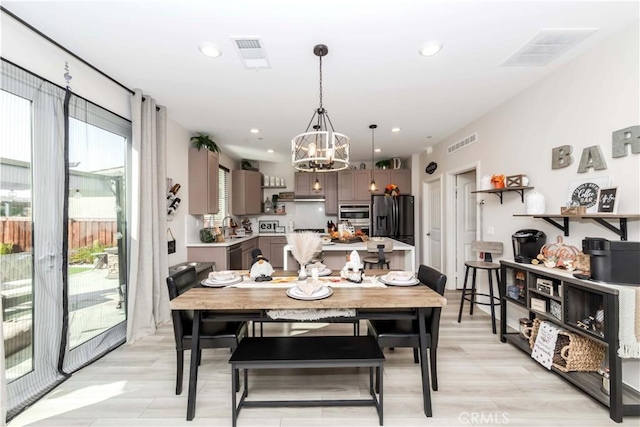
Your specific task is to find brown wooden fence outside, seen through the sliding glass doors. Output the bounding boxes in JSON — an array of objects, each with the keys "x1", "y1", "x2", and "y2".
[{"x1": 0, "y1": 217, "x2": 118, "y2": 253}]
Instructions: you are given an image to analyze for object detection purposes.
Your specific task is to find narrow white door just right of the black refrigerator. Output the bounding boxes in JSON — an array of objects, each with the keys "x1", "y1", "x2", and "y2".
[{"x1": 424, "y1": 179, "x2": 442, "y2": 271}]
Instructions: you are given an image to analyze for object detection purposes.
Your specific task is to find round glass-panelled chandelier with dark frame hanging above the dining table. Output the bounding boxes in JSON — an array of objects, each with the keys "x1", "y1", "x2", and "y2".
[{"x1": 291, "y1": 44, "x2": 349, "y2": 172}]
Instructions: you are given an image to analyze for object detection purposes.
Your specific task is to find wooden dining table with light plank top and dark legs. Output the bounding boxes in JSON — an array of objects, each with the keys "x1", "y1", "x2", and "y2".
[{"x1": 170, "y1": 270, "x2": 447, "y2": 421}]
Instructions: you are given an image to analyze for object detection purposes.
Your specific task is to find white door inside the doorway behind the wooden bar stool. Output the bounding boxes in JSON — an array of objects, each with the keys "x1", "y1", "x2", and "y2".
[{"x1": 455, "y1": 170, "x2": 477, "y2": 289}]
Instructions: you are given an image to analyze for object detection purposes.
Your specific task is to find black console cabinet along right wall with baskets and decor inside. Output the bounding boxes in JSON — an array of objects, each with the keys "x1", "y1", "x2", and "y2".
[{"x1": 500, "y1": 261, "x2": 640, "y2": 422}]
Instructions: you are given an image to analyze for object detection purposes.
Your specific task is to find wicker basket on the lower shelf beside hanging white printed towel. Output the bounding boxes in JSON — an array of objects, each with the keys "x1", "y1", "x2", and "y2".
[{"x1": 529, "y1": 319, "x2": 605, "y2": 372}]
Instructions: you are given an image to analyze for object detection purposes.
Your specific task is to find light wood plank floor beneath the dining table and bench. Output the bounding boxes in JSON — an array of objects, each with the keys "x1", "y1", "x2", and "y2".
[{"x1": 9, "y1": 292, "x2": 640, "y2": 427}]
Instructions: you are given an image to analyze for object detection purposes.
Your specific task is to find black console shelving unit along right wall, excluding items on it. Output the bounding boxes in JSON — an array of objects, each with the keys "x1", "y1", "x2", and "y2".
[{"x1": 500, "y1": 261, "x2": 640, "y2": 423}]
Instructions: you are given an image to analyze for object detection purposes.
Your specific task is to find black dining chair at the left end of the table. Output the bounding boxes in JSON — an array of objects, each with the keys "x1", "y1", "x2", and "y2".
[{"x1": 167, "y1": 267, "x2": 247, "y2": 394}]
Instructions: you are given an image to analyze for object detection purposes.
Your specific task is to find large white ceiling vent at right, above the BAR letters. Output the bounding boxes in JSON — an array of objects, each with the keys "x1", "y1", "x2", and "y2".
[{"x1": 502, "y1": 29, "x2": 598, "y2": 67}]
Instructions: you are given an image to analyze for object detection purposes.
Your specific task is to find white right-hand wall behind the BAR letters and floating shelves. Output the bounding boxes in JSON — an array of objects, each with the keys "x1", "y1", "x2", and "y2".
[{"x1": 415, "y1": 23, "x2": 640, "y2": 388}]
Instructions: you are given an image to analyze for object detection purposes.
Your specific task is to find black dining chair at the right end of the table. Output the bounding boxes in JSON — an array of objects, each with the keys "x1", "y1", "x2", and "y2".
[{"x1": 367, "y1": 265, "x2": 447, "y2": 391}]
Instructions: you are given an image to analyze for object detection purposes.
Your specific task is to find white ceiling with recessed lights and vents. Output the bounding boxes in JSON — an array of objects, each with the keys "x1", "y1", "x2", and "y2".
[{"x1": 2, "y1": 0, "x2": 638, "y2": 162}]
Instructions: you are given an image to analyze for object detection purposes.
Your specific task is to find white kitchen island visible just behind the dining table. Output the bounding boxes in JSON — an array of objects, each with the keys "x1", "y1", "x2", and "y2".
[{"x1": 284, "y1": 240, "x2": 416, "y2": 272}]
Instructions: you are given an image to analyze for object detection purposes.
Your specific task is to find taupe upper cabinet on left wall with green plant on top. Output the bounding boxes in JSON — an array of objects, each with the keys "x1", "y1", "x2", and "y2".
[{"x1": 188, "y1": 147, "x2": 220, "y2": 215}]
